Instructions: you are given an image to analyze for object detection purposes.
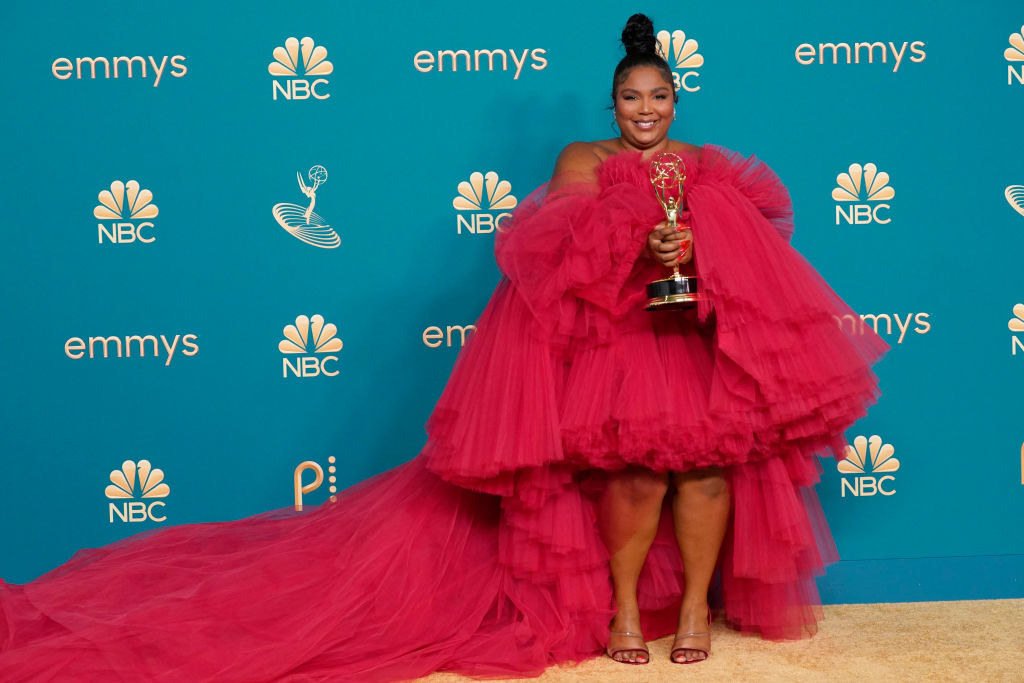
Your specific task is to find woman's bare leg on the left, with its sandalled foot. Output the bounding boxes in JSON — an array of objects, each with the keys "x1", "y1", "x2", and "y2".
[{"x1": 598, "y1": 467, "x2": 669, "y2": 661}]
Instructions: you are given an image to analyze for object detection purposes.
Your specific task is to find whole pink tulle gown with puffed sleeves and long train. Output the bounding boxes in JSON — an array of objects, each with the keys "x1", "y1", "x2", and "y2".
[{"x1": 0, "y1": 146, "x2": 885, "y2": 682}]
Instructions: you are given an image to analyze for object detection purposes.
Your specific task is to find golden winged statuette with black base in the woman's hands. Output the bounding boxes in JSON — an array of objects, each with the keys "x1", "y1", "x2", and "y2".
[{"x1": 647, "y1": 152, "x2": 700, "y2": 310}]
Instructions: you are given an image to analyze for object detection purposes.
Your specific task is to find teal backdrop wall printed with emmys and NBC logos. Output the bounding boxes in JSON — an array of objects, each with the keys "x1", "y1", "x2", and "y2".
[{"x1": 0, "y1": 0, "x2": 1024, "y2": 602}]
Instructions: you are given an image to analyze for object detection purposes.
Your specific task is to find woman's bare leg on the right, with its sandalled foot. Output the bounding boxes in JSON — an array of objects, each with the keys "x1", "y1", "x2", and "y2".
[{"x1": 672, "y1": 467, "x2": 729, "y2": 661}]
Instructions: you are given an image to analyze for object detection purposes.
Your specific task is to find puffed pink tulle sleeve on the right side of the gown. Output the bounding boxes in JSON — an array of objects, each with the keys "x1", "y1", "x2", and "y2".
[{"x1": 688, "y1": 147, "x2": 888, "y2": 456}]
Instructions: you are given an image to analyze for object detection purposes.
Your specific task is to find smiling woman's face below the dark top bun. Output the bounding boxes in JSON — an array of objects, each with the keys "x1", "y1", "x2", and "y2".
[{"x1": 615, "y1": 67, "x2": 676, "y2": 151}]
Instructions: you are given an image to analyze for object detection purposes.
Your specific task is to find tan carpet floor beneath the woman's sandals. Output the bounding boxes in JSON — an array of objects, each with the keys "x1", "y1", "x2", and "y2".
[{"x1": 420, "y1": 599, "x2": 1024, "y2": 683}]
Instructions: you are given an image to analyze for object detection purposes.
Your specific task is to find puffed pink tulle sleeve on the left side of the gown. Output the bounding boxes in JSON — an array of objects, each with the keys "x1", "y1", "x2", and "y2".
[{"x1": 427, "y1": 167, "x2": 664, "y2": 495}]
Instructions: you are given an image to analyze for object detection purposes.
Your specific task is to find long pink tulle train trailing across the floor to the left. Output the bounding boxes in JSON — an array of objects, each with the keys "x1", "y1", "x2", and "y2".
[{"x1": 0, "y1": 458, "x2": 610, "y2": 683}]
